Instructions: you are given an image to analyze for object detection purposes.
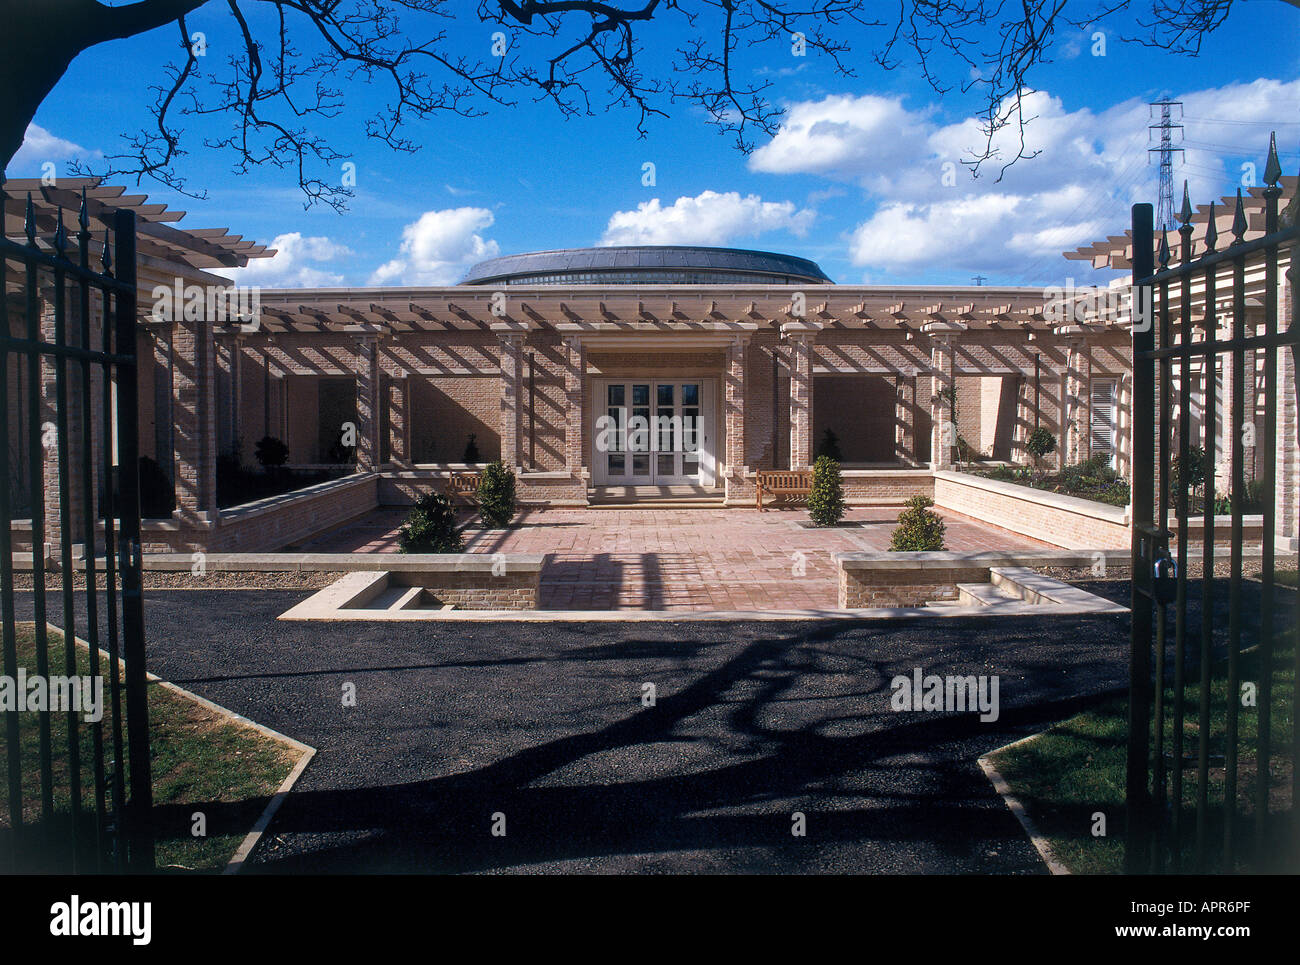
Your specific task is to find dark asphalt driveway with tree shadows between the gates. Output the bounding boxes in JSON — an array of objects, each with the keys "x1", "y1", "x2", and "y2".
[{"x1": 12, "y1": 590, "x2": 1149, "y2": 874}]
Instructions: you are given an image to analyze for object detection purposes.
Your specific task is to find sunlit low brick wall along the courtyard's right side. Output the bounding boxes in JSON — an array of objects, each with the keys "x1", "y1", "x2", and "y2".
[{"x1": 933, "y1": 471, "x2": 1131, "y2": 549}]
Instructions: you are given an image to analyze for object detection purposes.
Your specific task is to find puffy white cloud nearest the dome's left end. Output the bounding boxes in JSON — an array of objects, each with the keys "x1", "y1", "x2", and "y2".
[{"x1": 369, "y1": 208, "x2": 501, "y2": 285}]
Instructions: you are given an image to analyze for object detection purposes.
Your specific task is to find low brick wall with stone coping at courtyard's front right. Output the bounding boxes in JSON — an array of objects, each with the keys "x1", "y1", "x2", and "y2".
[{"x1": 835, "y1": 550, "x2": 1128, "y2": 610}]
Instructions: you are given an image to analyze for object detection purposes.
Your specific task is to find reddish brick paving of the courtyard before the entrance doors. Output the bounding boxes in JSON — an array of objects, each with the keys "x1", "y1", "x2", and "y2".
[{"x1": 299, "y1": 506, "x2": 1048, "y2": 610}]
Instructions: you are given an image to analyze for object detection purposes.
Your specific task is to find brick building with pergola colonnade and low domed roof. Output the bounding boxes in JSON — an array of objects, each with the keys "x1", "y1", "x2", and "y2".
[{"x1": 10, "y1": 178, "x2": 1296, "y2": 550}]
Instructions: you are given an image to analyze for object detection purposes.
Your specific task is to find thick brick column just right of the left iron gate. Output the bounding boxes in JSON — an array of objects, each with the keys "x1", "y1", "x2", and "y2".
[{"x1": 172, "y1": 317, "x2": 217, "y2": 523}]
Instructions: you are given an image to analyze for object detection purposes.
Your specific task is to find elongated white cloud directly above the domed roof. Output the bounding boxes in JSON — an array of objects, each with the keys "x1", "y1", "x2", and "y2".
[{"x1": 601, "y1": 191, "x2": 816, "y2": 245}]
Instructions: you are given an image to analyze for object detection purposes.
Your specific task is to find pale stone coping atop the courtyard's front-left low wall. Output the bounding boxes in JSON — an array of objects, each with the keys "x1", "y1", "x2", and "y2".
[{"x1": 143, "y1": 553, "x2": 546, "y2": 575}]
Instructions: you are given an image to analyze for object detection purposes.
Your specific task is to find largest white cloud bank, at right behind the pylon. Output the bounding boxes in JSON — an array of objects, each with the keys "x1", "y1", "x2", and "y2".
[{"x1": 750, "y1": 79, "x2": 1300, "y2": 282}]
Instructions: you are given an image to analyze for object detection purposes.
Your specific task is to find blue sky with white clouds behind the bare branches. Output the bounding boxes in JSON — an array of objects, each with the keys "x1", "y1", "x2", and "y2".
[{"x1": 9, "y1": 0, "x2": 1300, "y2": 286}]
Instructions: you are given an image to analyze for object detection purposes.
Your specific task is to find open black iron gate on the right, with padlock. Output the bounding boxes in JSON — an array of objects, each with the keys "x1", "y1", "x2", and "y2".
[{"x1": 1126, "y1": 133, "x2": 1300, "y2": 874}]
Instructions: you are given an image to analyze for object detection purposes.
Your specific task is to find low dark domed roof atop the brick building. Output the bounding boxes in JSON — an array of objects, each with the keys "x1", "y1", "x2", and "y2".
[{"x1": 460, "y1": 245, "x2": 833, "y2": 285}]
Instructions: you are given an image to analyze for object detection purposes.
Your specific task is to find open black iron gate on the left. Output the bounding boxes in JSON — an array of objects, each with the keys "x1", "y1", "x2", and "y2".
[{"x1": 0, "y1": 192, "x2": 153, "y2": 871}]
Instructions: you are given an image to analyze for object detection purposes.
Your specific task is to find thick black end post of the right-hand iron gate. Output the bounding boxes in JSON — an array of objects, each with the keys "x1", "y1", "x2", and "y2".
[{"x1": 1125, "y1": 204, "x2": 1164, "y2": 874}]
